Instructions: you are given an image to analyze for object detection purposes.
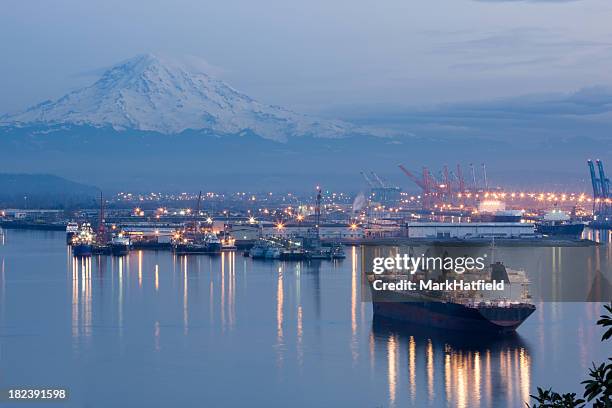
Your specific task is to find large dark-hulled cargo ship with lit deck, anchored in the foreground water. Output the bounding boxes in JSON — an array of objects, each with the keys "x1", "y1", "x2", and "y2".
[{"x1": 368, "y1": 262, "x2": 535, "y2": 334}]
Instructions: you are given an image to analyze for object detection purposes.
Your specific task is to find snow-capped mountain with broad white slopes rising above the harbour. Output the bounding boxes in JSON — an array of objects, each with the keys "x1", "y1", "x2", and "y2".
[{"x1": 0, "y1": 54, "x2": 359, "y2": 141}]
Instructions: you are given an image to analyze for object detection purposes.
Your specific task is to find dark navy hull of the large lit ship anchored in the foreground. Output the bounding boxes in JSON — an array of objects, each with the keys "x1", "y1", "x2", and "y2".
[{"x1": 373, "y1": 301, "x2": 535, "y2": 333}]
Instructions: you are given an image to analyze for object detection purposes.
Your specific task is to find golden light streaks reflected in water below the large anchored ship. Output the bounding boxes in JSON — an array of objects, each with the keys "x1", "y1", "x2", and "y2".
[{"x1": 372, "y1": 318, "x2": 531, "y2": 407}]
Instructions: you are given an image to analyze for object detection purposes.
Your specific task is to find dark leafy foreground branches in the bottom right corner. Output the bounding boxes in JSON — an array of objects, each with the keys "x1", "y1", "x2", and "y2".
[{"x1": 527, "y1": 302, "x2": 612, "y2": 408}]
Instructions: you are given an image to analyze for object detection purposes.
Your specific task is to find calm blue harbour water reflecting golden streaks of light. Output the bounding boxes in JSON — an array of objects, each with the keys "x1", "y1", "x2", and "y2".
[{"x1": 0, "y1": 231, "x2": 610, "y2": 407}]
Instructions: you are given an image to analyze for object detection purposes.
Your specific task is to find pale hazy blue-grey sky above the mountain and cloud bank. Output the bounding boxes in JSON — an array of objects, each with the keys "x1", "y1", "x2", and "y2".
[{"x1": 0, "y1": 0, "x2": 612, "y2": 113}]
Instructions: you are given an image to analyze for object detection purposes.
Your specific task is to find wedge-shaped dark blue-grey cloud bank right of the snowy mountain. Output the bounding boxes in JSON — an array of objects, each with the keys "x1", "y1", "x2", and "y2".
[{"x1": 328, "y1": 86, "x2": 612, "y2": 154}]
